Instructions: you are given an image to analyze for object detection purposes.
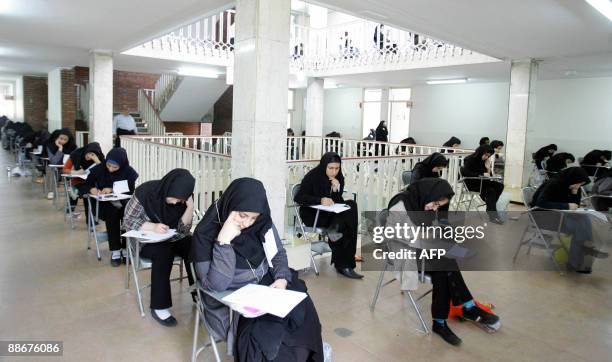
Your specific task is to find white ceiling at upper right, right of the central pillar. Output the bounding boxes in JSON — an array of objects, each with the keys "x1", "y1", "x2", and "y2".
[{"x1": 314, "y1": 0, "x2": 612, "y2": 78}]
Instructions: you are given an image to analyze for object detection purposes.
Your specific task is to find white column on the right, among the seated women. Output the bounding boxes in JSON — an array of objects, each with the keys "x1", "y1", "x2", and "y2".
[{"x1": 504, "y1": 60, "x2": 538, "y2": 201}]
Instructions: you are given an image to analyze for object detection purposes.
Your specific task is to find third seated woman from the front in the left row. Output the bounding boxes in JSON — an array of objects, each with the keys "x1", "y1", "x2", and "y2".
[{"x1": 85, "y1": 147, "x2": 138, "y2": 267}]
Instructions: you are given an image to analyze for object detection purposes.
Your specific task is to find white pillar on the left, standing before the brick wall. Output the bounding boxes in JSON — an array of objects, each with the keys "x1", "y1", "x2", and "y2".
[{"x1": 89, "y1": 50, "x2": 113, "y2": 153}]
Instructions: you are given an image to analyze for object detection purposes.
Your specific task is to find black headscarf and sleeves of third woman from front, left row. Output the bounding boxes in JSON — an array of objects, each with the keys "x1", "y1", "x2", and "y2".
[{"x1": 87, "y1": 147, "x2": 138, "y2": 191}]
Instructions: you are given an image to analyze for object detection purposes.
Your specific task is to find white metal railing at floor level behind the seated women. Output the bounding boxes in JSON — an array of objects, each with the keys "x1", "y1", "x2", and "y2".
[{"x1": 121, "y1": 136, "x2": 471, "y2": 215}]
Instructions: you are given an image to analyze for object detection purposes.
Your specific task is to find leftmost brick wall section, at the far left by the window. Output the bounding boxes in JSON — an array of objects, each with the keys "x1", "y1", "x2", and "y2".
[{"x1": 23, "y1": 76, "x2": 49, "y2": 131}]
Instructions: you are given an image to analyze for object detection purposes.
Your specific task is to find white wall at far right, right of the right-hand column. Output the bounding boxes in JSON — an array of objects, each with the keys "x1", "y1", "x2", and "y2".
[{"x1": 527, "y1": 78, "x2": 612, "y2": 158}]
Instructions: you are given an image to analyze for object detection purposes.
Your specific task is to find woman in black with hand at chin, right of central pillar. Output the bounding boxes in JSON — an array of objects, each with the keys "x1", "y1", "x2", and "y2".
[{"x1": 293, "y1": 152, "x2": 363, "y2": 279}]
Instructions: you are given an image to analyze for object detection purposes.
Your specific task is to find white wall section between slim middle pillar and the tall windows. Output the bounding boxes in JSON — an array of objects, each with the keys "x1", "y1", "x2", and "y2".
[{"x1": 323, "y1": 88, "x2": 363, "y2": 139}]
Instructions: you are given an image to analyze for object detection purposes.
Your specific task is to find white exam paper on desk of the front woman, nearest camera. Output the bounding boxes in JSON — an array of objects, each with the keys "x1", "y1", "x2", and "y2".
[{"x1": 222, "y1": 284, "x2": 306, "y2": 318}]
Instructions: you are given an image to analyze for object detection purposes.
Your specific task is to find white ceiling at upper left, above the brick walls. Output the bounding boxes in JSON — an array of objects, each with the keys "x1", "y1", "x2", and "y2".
[{"x1": 0, "y1": 0, "x2": 228, "y2": 74}]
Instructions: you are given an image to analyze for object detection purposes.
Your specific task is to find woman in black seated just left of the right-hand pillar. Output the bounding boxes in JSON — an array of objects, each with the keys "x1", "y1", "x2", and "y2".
[{"x1": 461, "y1": 145, "x2": 504, "y2": 224}]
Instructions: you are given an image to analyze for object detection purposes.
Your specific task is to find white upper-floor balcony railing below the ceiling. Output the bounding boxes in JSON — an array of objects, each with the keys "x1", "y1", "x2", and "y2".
[{"x1": 125, "y1": 10, "x2": 498, "y2": 76}]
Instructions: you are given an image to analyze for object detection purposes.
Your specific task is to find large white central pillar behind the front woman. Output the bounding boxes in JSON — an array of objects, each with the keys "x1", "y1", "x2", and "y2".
[{"x1": 232, "y1": 0, "x2": 291, "y2": 236}]
